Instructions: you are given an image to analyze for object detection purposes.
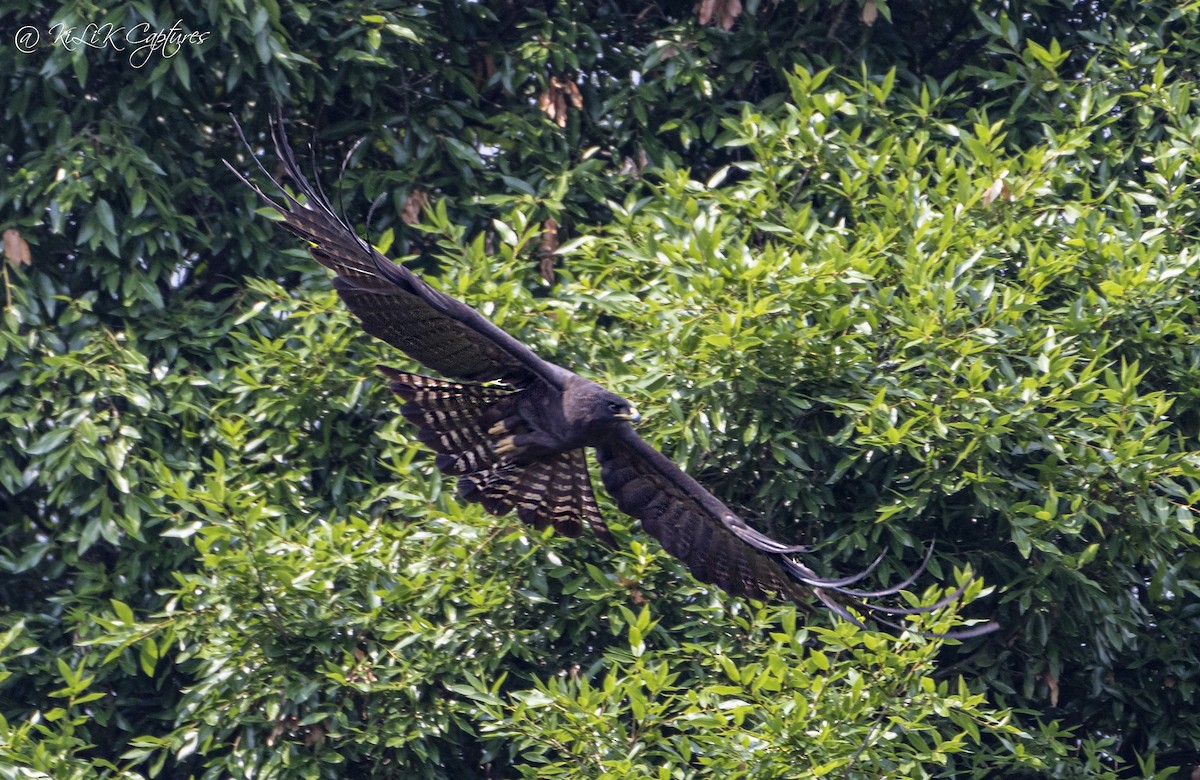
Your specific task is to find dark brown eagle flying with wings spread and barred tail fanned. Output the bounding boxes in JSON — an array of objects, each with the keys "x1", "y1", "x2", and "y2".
[{"x1": 226, "y1": 121, "x2": 980, "y2": 636}]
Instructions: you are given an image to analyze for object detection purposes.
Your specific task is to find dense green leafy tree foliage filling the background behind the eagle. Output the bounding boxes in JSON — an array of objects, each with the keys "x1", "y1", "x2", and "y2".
[{"x1": 0, "y1": 0, "x2": 1200, "y2": 779}]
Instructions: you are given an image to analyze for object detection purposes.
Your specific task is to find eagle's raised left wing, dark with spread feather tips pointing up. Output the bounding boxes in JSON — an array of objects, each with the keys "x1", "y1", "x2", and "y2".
[{"x1": 226, "y1": 121, "x2": 568, "y2": 388}]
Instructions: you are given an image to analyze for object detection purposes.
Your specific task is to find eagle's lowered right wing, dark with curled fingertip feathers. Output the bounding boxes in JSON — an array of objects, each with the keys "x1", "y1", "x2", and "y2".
[{"x1": 596, "y1": 426, "x2": 995, "y2": 638}]
